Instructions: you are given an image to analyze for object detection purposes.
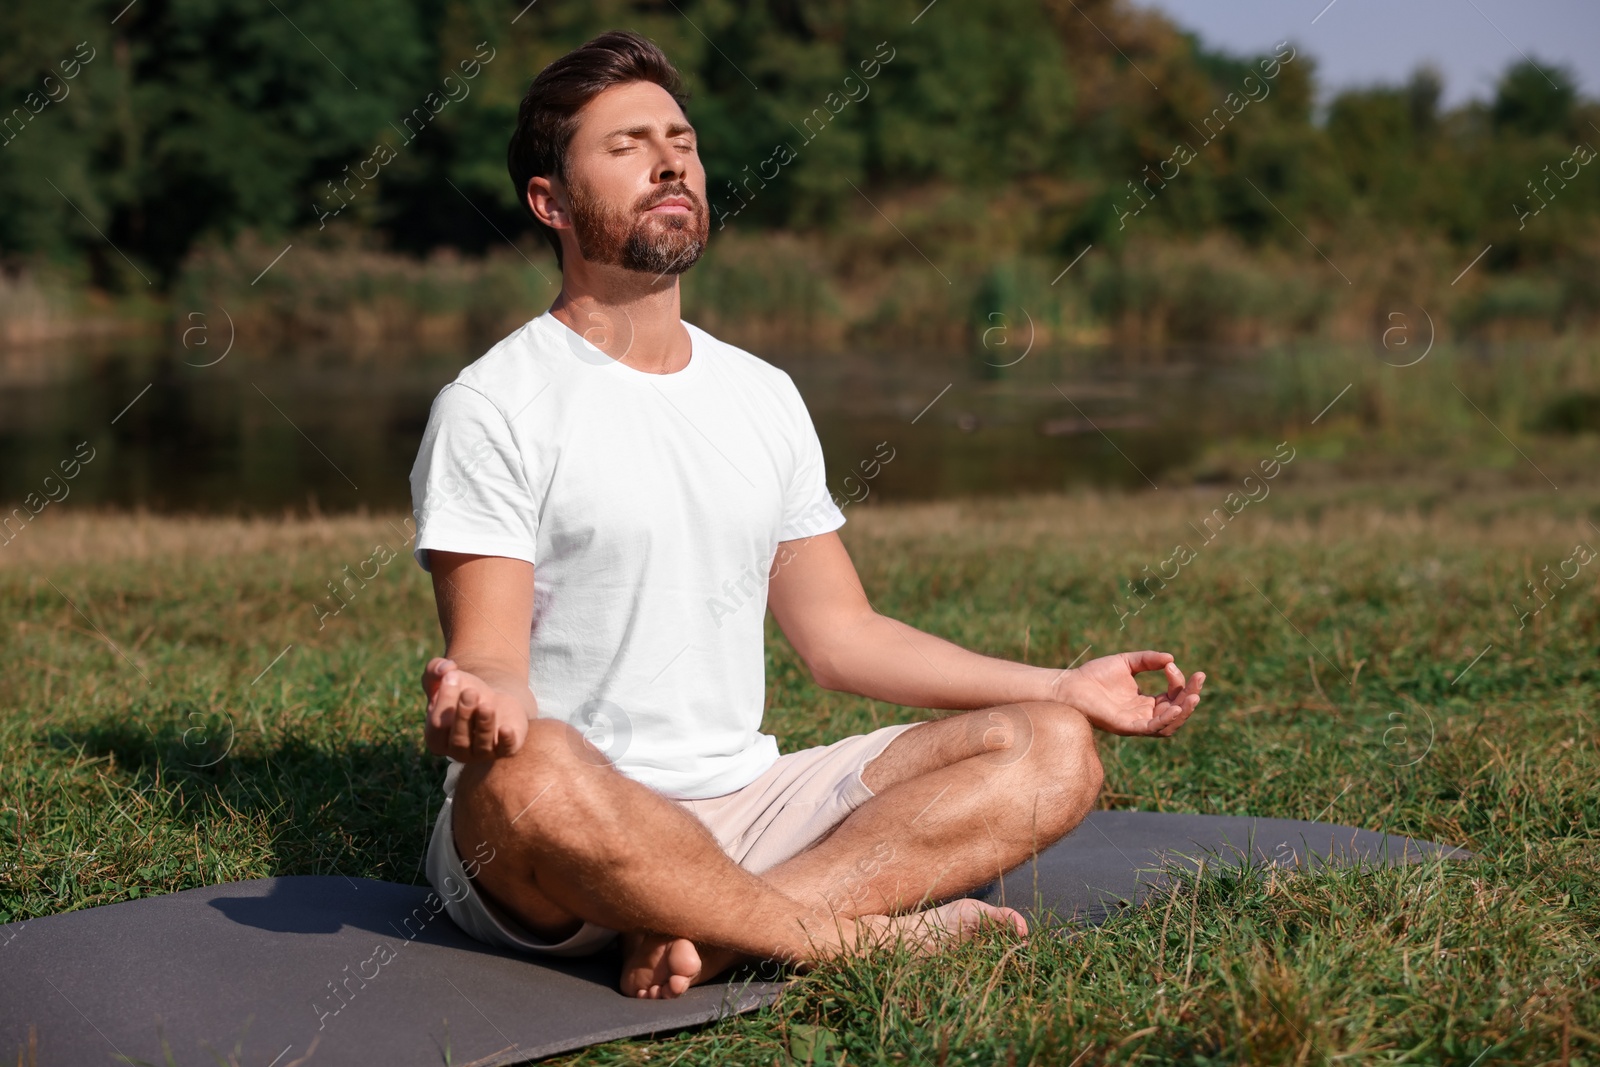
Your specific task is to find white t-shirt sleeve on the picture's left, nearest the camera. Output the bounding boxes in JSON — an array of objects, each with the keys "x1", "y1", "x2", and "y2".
[{"x1": 411, "y1": 382, "x2": 539, "y2": 571}]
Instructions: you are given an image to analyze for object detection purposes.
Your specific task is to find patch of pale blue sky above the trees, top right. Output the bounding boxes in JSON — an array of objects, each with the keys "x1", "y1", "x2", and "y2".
[{"x1": 1134, "y1": 0, "x2": 1600, "y2": 107}]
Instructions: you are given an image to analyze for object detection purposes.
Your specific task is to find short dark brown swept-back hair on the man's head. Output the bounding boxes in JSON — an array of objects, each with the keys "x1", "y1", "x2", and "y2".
[{"x1": 506, "y1": 30, "x2": 690, "y2": 266}]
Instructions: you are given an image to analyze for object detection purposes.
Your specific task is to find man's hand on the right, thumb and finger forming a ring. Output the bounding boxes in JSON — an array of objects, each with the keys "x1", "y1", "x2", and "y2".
[{"x1": 1051, "y1": 651, "x2": 1205, "y2": 737}]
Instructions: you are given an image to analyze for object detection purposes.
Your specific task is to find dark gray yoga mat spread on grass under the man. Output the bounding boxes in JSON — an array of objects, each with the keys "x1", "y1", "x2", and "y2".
[{"x1": 0, "y1": 811, "x2": 1467, "y2": 1067}]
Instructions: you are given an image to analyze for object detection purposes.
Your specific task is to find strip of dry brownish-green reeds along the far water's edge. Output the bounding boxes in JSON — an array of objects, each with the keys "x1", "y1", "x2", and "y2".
[{"x1": 12, "y1": 214, "x2": 1600, "y2": 362}]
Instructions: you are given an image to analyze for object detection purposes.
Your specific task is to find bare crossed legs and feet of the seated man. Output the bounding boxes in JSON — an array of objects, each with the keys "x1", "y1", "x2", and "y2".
[{"x1": 454, "y1": 702, "x2": 1101, "y2": 997}]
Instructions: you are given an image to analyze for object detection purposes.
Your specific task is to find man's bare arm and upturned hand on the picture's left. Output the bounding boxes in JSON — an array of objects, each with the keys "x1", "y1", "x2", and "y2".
[{"x1": 422, "y1": 549, "x2": 539, "y2": 761}]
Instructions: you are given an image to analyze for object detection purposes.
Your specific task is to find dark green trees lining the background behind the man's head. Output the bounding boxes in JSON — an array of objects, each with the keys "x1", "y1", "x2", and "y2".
[{"x1": 0, "y1": 0, "x2": 1600, "y2": 323}]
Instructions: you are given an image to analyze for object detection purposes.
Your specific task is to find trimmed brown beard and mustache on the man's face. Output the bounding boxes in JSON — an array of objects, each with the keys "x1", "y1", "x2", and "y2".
[{"x1": 568, "y1": 181, "x2": 710, "y2": 277}]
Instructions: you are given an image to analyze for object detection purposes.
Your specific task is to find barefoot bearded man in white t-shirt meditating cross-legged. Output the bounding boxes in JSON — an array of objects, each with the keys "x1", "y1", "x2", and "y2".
[{"x1": 411, "y1": 32, "x2": 1205, "y2": 998}]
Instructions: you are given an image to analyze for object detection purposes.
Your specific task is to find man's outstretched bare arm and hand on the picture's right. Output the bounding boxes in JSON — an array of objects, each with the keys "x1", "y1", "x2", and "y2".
[{"x1": 766, "y1": 533, "x2": 1205, "y2": 736}]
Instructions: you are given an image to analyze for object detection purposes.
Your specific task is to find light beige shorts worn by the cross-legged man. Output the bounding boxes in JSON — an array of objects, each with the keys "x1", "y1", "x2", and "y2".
[{"x1": 427, "y1": 723, "x2": 917, "y2": 957}]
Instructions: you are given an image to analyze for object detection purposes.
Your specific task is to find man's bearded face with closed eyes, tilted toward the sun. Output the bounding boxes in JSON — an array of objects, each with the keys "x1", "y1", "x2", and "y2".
[{"x1": 553, "y1": 82, "x2": 710, "y2": 275}]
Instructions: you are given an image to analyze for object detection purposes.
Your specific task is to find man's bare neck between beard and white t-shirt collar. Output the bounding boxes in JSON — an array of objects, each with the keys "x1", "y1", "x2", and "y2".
[{"x1": 550, "y1": 261, "x2": 691, "y2": 374}]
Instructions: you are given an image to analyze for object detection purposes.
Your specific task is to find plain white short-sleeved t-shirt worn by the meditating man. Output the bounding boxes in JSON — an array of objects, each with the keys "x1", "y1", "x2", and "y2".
[{"x1": 411, "y1": 312, "x2": 845, "y2": 798}]
